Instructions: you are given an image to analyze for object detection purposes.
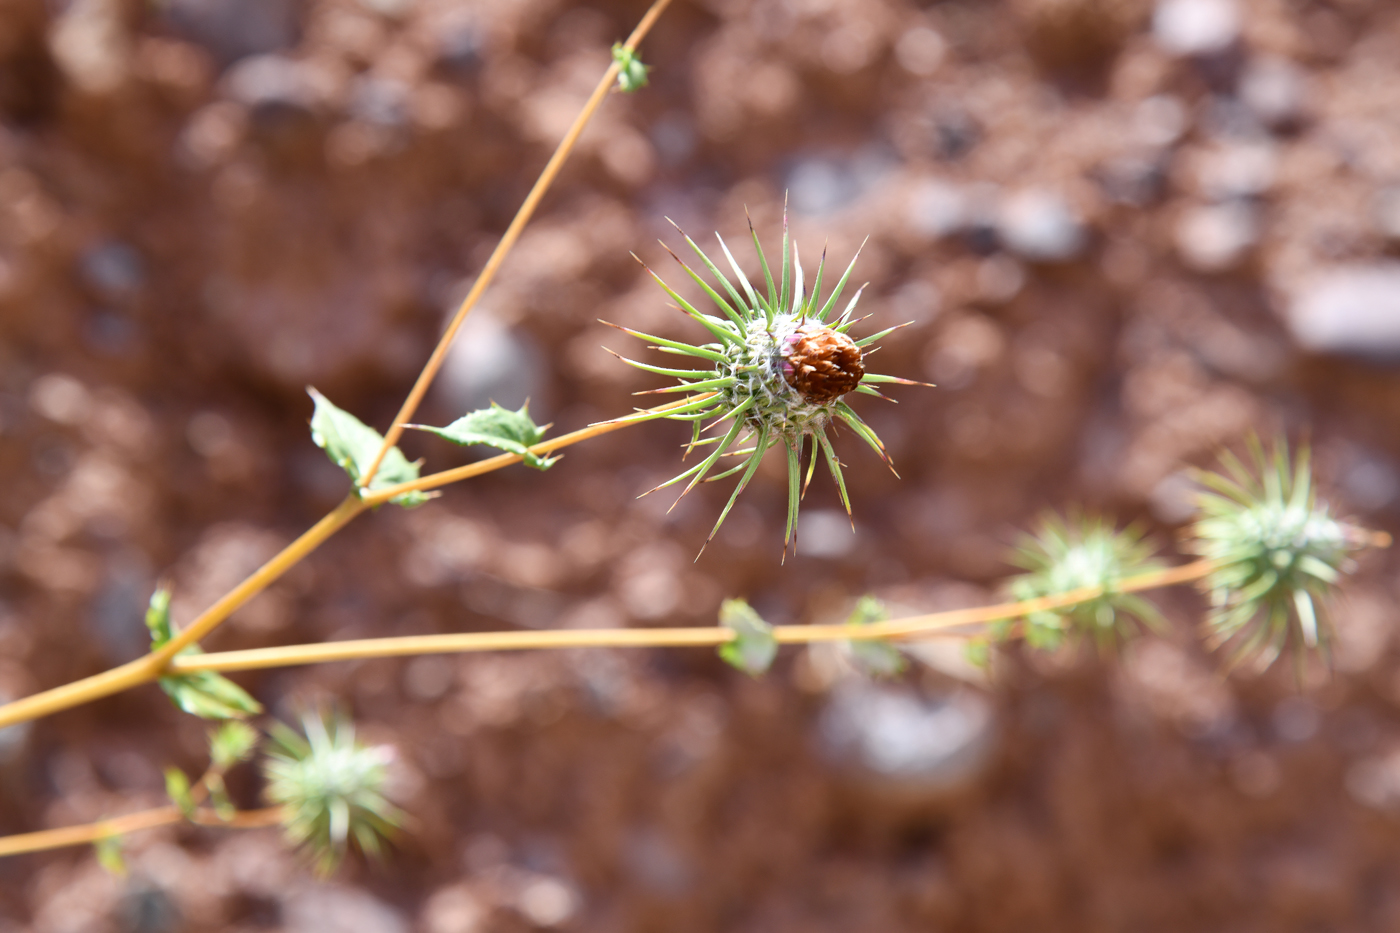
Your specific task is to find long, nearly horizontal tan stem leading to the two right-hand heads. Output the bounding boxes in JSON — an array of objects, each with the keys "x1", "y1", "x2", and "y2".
[{"x1": 171, "y1": 560, "x2": 1215, "y2": 672}]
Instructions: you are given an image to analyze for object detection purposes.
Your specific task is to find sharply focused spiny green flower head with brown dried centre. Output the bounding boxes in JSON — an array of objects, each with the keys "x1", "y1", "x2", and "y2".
[{"x1": 607, "y1": 216, "x2": 924, "y2": 553}]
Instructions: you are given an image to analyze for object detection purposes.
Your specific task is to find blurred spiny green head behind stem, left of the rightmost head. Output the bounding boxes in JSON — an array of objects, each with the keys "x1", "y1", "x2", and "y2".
[{"x1": 1011, "y1": 514, "x2": 1163, "y2": 647}]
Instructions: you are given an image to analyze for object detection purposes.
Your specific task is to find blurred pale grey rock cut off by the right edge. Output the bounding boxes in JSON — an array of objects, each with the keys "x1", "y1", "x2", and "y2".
[{"x1": 1288, "y1": 262, "x2": 1400, "y2": 363}]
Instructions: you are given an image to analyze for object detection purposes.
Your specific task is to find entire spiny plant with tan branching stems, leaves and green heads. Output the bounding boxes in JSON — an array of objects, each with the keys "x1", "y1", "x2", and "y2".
[{"x1": 0, "y1": 0, "x2": 1389, "y2": 870}]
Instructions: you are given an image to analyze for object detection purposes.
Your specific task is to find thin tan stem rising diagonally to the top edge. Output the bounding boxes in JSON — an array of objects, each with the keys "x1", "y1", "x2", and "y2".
[{"x1": 360, "y1": 0, "x2": 671, "y2": 488}]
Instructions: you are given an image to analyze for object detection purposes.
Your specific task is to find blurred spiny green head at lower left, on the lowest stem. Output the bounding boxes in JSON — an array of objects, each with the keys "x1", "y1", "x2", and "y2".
[{"x1": 263, "y1": 714, "x2": 400, "y2": 874}]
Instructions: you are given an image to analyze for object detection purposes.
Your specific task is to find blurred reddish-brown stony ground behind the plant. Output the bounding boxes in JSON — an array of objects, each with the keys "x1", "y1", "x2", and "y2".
[{"x1": 0, "y1": 0, "x2": 1400, "y2": 933}]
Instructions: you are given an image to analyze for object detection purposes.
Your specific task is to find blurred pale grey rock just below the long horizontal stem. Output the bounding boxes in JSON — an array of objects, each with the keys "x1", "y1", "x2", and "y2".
[{"x1": 819, "y1": 678, "x2": 995, "y2": 796}]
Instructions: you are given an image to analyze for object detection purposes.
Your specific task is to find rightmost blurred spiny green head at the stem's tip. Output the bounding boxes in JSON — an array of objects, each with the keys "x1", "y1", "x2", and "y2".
[{"x1": 1190, "y1": 438, "x2": 1376, "y2": 667}]
